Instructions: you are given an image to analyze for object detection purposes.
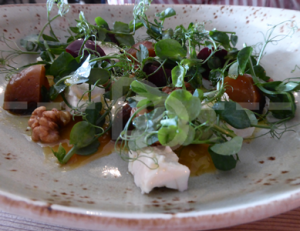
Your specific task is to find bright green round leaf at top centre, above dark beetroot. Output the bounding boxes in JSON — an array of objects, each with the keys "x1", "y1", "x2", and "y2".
[{"x1": 154, "y1": 39, "x2": 187, "y2": 61}]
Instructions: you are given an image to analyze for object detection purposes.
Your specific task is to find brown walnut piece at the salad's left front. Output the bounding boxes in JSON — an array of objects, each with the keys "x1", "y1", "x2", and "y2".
[{"x1": 28, "y1": 106, "x2": 71, "y2": 143}]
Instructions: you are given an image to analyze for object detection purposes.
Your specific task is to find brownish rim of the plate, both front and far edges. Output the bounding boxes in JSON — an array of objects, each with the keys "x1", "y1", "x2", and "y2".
[{"x1": 0, "y1": 3, "x2": 300, "y2": 230}]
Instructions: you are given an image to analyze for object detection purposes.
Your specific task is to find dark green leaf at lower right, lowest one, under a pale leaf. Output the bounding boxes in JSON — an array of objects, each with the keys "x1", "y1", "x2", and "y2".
[{"x1": 208, "y1": 148, "x2": 237, "y2": 171}]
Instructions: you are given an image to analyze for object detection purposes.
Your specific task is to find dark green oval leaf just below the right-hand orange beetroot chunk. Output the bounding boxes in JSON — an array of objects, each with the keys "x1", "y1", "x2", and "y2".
[{"x1": 213, "y1": 101, "x2": 251, "y2": 129}]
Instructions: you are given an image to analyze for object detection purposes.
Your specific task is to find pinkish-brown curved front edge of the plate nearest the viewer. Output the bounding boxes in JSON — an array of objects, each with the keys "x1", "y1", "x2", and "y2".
[{"x1": 0, "y1": 189, "x2": 300, "y2": 231}]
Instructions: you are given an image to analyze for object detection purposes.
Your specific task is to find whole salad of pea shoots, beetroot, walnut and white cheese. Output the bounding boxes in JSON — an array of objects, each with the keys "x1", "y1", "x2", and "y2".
[{"x1": 1, "y1": 0, "x2": 300, "y2": 193}]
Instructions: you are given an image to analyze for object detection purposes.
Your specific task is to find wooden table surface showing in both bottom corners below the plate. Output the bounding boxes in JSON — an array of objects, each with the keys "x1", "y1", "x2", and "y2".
[{"x1": 0, "y1": 208, "x2": 300, "y2": 231}]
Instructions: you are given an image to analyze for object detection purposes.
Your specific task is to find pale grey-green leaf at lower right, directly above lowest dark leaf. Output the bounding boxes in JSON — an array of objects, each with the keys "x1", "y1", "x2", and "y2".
[{"x1": 210, "y1": 136, "x2": 243, "y2": 155}]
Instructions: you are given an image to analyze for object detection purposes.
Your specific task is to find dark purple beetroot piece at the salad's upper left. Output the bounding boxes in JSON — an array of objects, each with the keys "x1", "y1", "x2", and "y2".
[{"x1": 66, "y1": 39, "x2": 106, "y2": 58}]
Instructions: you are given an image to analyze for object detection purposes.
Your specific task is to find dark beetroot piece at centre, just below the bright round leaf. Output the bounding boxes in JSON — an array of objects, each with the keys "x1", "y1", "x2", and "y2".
[{"x1": 143, "y1": 63, "x2": 171, "y2": 87}]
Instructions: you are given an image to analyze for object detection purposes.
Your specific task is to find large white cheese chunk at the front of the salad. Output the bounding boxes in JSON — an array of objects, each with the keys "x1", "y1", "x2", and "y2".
[{"x1": 128, "y1": 146, "x2": 190, "y2": 194}]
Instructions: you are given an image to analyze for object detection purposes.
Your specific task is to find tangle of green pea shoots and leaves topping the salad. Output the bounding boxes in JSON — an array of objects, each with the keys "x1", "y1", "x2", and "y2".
[{"x1": 1, "y1": 0, "x2": 300, "y2": 174}]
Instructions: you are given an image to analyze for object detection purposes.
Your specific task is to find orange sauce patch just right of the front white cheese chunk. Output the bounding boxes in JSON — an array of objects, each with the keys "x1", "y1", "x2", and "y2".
[{"x1": 175, "y1": 144, "x2": 216, "y2": 176}]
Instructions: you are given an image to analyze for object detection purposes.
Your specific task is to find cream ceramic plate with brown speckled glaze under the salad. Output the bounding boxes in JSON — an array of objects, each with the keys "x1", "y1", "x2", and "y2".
[{"x1": 0, "y1": 5, "x2": 300, "y2": 230}]
